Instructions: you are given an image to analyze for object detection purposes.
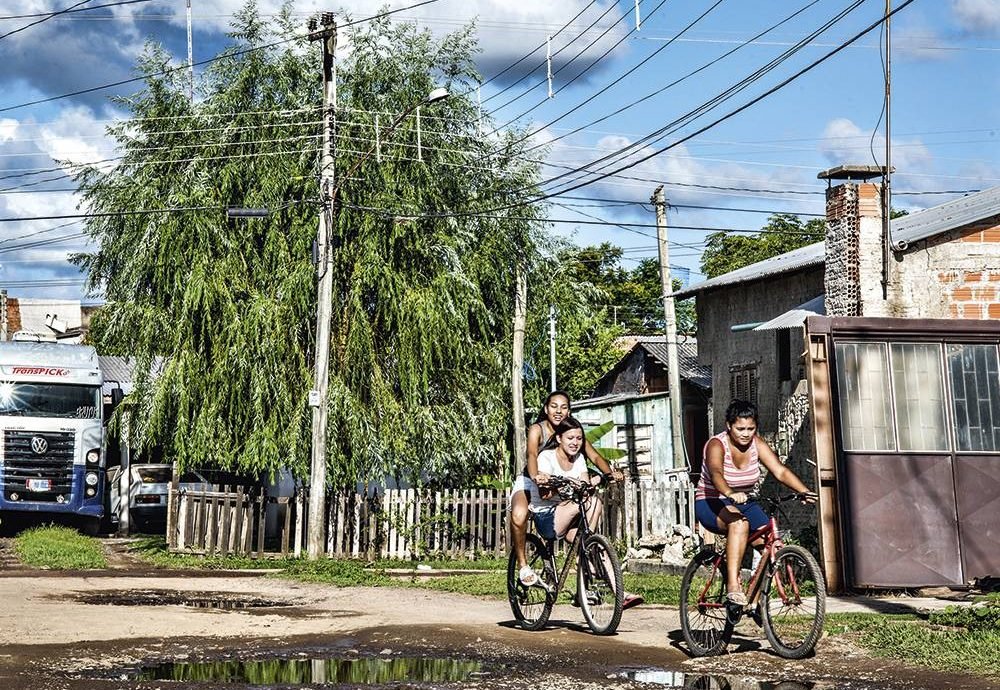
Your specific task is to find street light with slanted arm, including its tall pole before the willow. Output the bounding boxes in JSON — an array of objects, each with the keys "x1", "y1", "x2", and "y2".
[{"x1": 306, "y1": 74, "x2": 449, "y2": 560}]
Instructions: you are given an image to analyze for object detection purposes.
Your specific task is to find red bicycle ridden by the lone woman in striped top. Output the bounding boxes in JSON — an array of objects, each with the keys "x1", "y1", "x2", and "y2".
[{"x1": 680, "y1": 493, "x2": 826, "y2": 659}]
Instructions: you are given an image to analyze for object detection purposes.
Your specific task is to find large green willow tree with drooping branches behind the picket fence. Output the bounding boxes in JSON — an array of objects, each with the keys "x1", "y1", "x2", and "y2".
[{"x1": 79, "y1": 3, "x2": 537, "y2": 486}]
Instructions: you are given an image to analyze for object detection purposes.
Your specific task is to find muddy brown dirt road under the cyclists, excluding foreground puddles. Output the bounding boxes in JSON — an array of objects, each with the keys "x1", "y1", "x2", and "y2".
[{"x1": 0, "y1": 567, "x2": 992, "y2": 690}]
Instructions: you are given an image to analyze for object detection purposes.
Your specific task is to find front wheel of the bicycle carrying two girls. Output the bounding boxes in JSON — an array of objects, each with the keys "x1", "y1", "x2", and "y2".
[{"x1": 576, "y1": 534, "x2": 625, "y2": 635}]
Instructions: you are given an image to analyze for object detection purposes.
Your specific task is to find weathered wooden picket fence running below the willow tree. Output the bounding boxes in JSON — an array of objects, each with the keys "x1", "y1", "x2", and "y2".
[{"x1": 168, "y1": 483, "x2": 695, "y2": 559}]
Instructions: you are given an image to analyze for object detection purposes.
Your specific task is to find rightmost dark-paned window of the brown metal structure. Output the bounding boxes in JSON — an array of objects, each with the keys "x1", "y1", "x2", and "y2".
[{"x1": 946, "y1": 345, "x2": 1000, "y2": 451}]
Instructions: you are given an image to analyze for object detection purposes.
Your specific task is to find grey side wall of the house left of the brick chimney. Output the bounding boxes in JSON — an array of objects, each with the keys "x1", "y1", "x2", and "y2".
[{"x1": 696, "y1": 266, "x2": 823, "y2": 440}]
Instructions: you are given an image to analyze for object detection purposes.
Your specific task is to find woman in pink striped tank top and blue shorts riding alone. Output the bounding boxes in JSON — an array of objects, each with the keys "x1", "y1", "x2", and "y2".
[{"x1": 694, "y1": 400, "x2": 816, "y2": 606}]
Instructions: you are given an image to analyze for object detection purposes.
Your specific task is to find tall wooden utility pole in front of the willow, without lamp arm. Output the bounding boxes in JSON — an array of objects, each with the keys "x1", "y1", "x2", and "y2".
[{"x1": 306, "y1": 12, "x2": 337, "y2": 560}]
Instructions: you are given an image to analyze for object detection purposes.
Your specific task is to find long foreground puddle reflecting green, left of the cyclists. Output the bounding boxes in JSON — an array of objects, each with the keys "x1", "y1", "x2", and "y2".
[{"x1": 132, "y1": 657, "x2": 483, "y2": 686}]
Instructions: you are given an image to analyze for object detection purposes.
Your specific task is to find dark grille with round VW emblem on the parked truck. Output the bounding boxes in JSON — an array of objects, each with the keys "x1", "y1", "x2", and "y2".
[{"x1": 2, "y1": 430, "x2": 75, "y2": 503}]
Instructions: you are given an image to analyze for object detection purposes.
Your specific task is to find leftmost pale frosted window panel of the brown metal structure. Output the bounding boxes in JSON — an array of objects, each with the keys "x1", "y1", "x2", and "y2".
[{"x1": 836, "y1": 343, "x2": 896, "y2": 451}]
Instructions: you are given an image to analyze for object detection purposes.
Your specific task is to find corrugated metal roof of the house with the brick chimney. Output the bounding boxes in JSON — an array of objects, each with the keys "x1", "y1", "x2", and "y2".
[{"x1": 674, "y1": 187, "x2": 1000, "y2": 299}]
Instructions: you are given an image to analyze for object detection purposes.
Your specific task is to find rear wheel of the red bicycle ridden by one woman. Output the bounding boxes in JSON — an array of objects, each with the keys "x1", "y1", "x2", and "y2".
[{"x1": 680, "y1": 548, "x2": 733, "y2": 656}]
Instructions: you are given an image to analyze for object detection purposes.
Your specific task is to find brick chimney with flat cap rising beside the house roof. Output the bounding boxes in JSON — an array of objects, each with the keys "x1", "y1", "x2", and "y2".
[{"x1": 817, "y1": 165, "x2": 888, "y2": 316}]
